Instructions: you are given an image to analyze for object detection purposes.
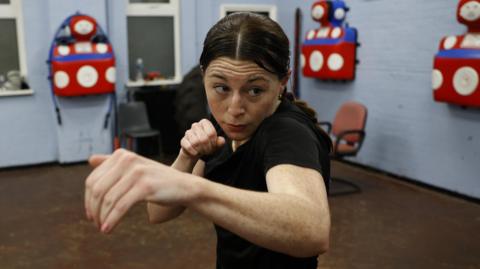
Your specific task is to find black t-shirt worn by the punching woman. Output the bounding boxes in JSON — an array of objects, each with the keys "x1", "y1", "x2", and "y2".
[{"x1": 202, "y1": 100, "x2": 330, "y2": 269}]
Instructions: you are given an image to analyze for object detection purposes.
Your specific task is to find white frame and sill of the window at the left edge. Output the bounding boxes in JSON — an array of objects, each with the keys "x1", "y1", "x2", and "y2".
[{"x1": 0, "y1": 0, "x2": 33, "y2": 96}]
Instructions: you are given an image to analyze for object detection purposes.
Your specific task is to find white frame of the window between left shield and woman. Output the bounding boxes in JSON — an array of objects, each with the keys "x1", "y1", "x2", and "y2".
[{"x1": 126, "y1": 0, "x2": 182, "y2": 87}]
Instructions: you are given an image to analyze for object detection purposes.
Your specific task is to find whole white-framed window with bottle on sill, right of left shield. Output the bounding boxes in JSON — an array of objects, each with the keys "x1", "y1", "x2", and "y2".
[{"x1": 127, "y1": 0, "x2": 182, "y2": 86}]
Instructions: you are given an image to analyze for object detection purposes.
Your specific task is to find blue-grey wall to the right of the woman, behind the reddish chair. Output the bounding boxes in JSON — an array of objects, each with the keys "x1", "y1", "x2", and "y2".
[{"x1": 279, "y1": 0, "x2": 480, "y2": 198}]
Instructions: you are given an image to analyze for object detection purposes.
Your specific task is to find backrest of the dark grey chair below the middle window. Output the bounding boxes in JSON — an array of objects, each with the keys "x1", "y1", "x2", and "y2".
[{"x1": 118, "y1": 102, "x2": 150, "y2": 134}]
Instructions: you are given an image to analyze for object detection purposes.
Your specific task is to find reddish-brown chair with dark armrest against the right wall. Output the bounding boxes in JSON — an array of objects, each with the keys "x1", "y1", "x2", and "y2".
[{"x1": 319, "y1": 101, "x2": 367, "y2": 196}]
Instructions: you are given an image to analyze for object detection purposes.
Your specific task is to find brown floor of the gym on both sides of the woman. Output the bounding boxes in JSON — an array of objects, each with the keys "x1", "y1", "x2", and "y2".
[{"x1": 0, "y1": 160, "x2": 480, "y2": 269}]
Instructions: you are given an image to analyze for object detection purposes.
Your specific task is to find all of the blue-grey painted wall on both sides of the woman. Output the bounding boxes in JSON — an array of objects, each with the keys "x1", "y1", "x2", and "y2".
[{"x1": 0, "y1": 0, "x2": 480, "y2": 198}]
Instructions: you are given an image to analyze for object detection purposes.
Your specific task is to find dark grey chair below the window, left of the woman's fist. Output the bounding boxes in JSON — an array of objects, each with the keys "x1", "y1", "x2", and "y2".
[{"x1": 118, "y1": 102, "x2": 162, "y2": 154}]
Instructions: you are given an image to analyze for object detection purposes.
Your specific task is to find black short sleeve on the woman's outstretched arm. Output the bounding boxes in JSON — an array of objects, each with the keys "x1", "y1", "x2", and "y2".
[{"x1": 263, "y1": 117, "x2": 322, "y2": 173}]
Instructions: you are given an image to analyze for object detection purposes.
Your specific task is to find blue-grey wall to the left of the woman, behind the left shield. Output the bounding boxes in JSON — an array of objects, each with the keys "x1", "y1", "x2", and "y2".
[{"x1": 0, "y1": 0, "x2": 197, "y2": 167}]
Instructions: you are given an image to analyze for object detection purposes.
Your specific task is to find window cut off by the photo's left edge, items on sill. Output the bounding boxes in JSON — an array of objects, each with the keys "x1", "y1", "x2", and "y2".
[{"x1": 0, "y1": 0, "x2": 32, "y2": 96}]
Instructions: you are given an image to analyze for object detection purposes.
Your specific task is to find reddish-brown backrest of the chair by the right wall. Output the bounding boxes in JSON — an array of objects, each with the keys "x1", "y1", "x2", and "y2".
[{"x1": 332, "y1": 101, "x2": 367, "y2": 144}]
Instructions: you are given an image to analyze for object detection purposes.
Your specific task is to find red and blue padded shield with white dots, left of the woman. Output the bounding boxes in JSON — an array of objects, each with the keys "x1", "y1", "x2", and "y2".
[{"x1": 48, "y1": 13, "x2": 115, "y2": 96}]
